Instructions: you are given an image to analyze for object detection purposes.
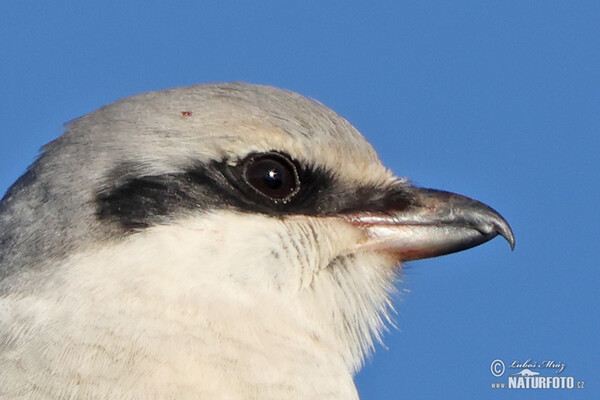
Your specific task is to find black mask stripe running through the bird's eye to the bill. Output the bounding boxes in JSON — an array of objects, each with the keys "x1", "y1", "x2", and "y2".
[{"x1": 96, "y1": 152, "x2": 412, "y2": 231}]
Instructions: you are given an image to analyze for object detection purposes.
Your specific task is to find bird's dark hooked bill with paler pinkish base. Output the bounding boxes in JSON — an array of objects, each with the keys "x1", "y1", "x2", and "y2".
[{"x1": 343, "y1": 187, "x2": 515, "y2": 261}]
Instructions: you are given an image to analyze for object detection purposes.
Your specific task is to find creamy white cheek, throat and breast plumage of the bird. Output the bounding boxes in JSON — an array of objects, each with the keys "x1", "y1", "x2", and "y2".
[{"x1": 0, "y1": 214, "x2": 394, "y2": 399}]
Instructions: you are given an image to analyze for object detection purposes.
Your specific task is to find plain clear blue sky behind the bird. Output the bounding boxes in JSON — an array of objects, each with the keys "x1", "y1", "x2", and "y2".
[{"x1": 0, "y1": 0, "x2": 600, "y2": 399}]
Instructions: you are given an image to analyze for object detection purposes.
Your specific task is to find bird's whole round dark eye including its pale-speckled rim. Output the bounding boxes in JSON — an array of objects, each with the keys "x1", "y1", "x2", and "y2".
[{"x1": 244, "y1": 153, "x2": 300, "y2": 200}]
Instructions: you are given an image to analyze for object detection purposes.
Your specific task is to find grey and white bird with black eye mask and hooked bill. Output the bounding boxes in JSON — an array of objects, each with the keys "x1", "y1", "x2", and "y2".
[{"x1": 0, "y1": 82, "x2": 515, "y2": 400}]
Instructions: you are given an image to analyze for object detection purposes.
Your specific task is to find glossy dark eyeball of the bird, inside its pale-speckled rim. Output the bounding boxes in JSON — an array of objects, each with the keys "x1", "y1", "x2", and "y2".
[{"x1": 246, "y1": 158, "x2": 296, "y2": 199}]
